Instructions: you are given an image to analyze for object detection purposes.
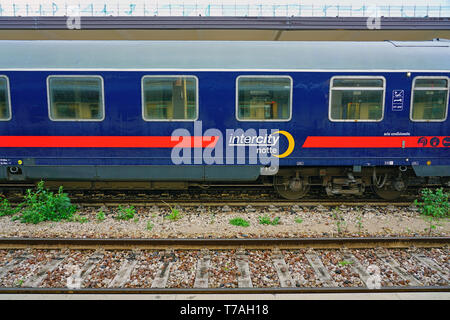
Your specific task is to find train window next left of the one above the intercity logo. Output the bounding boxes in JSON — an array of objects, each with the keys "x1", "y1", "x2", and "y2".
[{"x1": 142, "y1": 76, "x2": 198, "y2": 121}]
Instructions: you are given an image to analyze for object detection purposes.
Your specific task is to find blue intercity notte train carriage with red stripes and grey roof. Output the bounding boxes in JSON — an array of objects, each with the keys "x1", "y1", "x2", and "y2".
[{"x1": 0, "y1": 40, "x2": 450, "y2": 199}]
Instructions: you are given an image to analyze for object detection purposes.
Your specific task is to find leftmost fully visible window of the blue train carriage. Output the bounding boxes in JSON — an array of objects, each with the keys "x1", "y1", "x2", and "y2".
[{"x1": 47, "y1": 76, "x2": 105, "y2": 121}]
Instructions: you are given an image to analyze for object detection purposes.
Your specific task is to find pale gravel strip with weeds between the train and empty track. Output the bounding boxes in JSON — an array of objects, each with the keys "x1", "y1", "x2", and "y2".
[{"x1": 0, "y1": 206, "x2": 450, "y2": 238}]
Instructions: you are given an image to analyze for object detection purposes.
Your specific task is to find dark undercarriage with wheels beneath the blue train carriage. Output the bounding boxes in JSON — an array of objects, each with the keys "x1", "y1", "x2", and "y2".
[{"x1": 0, "y1": 166, "x2": 450, "y2": 200}]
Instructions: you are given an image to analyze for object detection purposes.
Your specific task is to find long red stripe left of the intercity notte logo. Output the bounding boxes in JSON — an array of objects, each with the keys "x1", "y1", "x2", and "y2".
[{"x1": 0, "y1": 136, "x2": 219, "y2": 148}]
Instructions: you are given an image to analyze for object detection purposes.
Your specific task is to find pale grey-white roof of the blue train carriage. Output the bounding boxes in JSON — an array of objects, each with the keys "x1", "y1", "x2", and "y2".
[{"x1": 0, "y1": 40, "x2": 450, "y2": 71}]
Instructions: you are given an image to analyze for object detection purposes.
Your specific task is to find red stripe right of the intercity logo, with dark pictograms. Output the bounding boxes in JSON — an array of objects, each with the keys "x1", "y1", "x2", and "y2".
[{"x1": 302, "y1": 136, "x2": 450, "y2": 148}]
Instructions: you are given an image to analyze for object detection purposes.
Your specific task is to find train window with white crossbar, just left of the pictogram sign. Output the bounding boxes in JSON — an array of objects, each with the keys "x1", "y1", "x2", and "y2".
[{"x1": 329, "y1": 77, "x2": 386, "y2": 122}]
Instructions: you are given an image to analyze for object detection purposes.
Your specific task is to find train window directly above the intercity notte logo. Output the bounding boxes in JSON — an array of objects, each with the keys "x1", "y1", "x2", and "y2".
[{"x1": 236, "y1": 76, "x2": 292, "y2": 121}]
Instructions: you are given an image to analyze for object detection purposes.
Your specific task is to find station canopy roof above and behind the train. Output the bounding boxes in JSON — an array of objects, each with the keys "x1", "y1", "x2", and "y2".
[{"x1": 0, "y1": 0, "x2": 450, "y2": 41}]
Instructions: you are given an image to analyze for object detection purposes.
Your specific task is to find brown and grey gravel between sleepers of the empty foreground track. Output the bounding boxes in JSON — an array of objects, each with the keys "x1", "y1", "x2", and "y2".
[{"x1": 0, "y1": 248, "x2": 450, "y2": 289}]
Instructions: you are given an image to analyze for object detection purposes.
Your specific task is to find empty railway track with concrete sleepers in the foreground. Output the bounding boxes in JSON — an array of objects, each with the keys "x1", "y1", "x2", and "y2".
[{"x1": 0, "y1": 237, "x2": 450, "y2": 294}]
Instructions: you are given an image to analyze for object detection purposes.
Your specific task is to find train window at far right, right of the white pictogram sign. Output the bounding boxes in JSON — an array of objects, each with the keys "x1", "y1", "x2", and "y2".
[{"x1": 410, "y1": 77, "x2": 449, "y2": 121}]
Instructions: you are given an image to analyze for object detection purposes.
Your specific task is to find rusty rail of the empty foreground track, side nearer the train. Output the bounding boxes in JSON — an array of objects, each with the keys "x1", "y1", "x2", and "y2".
[{"x1": 0, "y1": 237, "x2": 450, "y2": 250}]
